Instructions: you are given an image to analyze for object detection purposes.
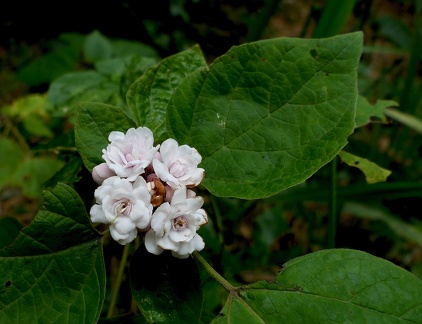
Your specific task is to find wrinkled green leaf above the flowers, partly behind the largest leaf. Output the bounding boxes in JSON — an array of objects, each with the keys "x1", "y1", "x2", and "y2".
[{"x1": 126, "y1": 46, "x2": 207, "y2": 141}]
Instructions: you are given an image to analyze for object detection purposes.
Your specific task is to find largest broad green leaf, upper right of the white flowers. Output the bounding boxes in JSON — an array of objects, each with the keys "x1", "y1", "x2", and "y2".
[{"x1": 167, "y1": 32, "x2": 362, "y2": 199}]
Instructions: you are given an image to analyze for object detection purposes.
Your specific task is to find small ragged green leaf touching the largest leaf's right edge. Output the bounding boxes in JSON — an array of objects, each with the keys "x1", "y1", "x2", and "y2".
[{"x1": 355, "y1": 96, "x2": 399, "y2": 128}]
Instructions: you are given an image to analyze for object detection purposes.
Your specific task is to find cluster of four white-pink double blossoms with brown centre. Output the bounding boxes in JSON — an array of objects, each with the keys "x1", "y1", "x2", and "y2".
[{"x1": 90, "y1": 127, "x2": 208, "y2": 259}]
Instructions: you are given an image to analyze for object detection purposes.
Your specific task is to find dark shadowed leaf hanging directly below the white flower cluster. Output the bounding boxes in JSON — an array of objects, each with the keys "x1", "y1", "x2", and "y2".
[{"x1": 130, "y1": 246, "x2": 203, "y2": 323}]
